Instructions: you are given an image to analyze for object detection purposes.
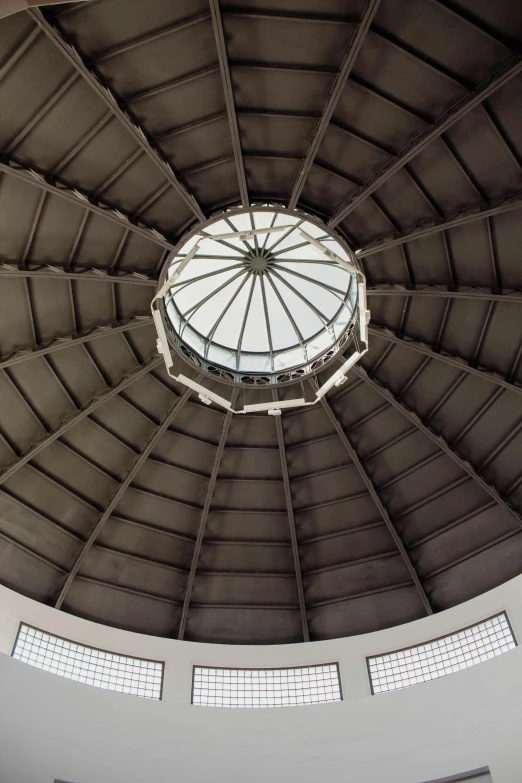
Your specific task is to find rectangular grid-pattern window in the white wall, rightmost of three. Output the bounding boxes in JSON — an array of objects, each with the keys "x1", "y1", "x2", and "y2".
[{"x1": 368, "y1": 612, "x2": 516, "y2": 693}]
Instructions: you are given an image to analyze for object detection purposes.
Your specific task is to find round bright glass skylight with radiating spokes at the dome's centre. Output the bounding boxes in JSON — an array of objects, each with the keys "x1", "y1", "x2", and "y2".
[{"x1": 164, "y1": 207, "x2": 357, "y2": 383}]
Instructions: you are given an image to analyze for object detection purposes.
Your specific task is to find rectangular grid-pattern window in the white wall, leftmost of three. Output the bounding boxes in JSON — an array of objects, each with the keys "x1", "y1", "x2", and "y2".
[{"x1": 13, "y1": 623, "x2": 163, "y2": 699}]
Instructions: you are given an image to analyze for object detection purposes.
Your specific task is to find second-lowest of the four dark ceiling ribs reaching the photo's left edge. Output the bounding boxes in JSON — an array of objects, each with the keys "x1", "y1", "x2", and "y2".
[{"x1": 0, "y1": 311, "x2": 152, "y2": 370}]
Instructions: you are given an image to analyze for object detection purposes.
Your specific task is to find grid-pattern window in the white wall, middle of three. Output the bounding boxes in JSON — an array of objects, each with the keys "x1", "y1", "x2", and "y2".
[{"x1": 192, "y1": 663, "x2": 342, "y2": 707}]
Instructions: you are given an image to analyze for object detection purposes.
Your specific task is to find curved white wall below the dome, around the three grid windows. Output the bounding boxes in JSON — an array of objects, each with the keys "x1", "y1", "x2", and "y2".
[{"x1": 0, "y1": 577, "x2": 522, "y2": 783}]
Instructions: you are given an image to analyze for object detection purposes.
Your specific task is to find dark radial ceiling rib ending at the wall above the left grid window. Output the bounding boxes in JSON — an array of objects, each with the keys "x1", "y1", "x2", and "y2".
[{"x1": 55, "y1": 389, "x2": 192, "y2": 609}]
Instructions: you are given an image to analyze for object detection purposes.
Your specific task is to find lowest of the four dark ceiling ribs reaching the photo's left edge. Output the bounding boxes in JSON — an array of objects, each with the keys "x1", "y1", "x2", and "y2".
[{"x1": 0, "y1": 352, "x2": 163, "y2": 484}]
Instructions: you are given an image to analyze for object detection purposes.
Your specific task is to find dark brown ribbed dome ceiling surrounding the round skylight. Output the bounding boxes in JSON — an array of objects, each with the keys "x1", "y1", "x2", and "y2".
[{"x1": 0, "y1": 0, "x2": 522, "y2": 644}]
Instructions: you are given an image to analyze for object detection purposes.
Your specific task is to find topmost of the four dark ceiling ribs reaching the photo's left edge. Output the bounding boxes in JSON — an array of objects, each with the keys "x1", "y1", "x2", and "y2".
[{"x1": 0, "y1": 155, "x2": 174, "y2": 250}]
